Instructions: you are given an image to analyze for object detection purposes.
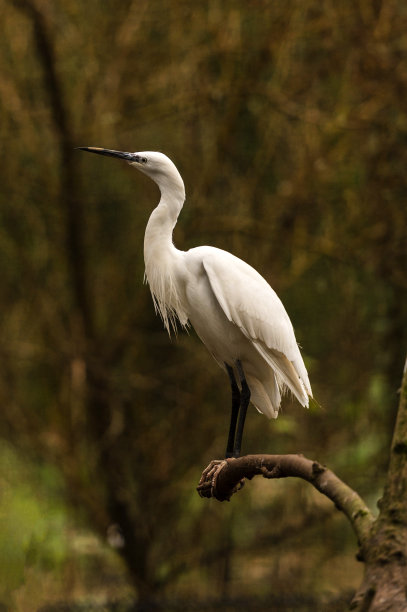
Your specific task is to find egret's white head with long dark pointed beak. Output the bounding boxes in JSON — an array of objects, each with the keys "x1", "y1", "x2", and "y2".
[{"x1": 78, "y1": 147, "x2": 185, "y2": 194}]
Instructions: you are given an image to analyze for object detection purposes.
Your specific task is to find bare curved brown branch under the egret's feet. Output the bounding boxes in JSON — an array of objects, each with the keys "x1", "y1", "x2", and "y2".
[{"x1": 197, "y1": 455, "x2": 374, "y2": 550}]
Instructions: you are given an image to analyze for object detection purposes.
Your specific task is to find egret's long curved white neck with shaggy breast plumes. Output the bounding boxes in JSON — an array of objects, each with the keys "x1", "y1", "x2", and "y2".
[{"x1": 144, "y1": 175, "x2": 187, "y2": 332}]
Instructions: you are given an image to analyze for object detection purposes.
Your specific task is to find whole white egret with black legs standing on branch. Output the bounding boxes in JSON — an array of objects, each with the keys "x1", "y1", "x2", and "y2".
[{"x1": 79, "y1": 147, "x2": 312, "y2": 457}]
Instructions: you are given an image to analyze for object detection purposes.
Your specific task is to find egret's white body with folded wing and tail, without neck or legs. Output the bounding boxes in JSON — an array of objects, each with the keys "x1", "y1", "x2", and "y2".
[{"x1": 186, "y1": 247, "x2": 310, "y2": 418}]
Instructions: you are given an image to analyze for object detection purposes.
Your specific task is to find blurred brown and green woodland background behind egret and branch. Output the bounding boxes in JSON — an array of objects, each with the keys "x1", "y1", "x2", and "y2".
[{"x1": 0, "y1": 0, "x2": 407, "y2": 612}]
